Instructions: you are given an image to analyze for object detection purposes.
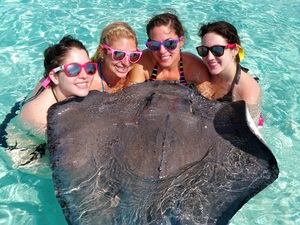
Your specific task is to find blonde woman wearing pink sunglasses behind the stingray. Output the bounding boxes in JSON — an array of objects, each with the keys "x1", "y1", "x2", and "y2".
[{"x1": 91, "y1": 22, "x2": 142, "y2": 93}]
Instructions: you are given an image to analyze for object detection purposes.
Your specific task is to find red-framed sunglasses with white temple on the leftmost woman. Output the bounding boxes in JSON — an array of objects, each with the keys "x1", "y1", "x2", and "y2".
[{"x1": 51, "y1": 62, "x2": 97, "y2": 77}]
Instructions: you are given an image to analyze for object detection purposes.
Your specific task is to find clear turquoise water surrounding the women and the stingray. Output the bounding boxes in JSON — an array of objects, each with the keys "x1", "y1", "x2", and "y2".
[{"x1": 0, "y1": 0, "x2": 300, "y2": 225}]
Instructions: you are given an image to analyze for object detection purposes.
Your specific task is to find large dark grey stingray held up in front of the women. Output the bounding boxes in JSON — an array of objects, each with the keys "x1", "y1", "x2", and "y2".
[{"x1": 48, "y1": 81, "x2": 279, "y2": 225}]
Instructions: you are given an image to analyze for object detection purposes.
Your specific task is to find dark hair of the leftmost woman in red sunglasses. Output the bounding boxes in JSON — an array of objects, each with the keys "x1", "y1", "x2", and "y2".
[{"x1": 44, "y1": 35, "x2": 88, "y2": 77}]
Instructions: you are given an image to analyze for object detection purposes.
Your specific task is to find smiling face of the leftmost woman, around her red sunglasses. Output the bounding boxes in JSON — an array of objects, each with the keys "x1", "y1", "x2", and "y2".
[{"x1": 54, "y1": 48, "x2": 94, "y2": 98}]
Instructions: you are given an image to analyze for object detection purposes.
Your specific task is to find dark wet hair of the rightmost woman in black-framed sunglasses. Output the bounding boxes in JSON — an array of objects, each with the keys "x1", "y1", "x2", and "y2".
[{"x1": 198, "y1": 21, "x2": 241, "y2": 63}]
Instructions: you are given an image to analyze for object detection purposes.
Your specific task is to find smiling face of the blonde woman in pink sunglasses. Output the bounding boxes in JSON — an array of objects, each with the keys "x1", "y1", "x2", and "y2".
[{"x1": 103, "y1": 38, "x2": 137, "y2": 78}]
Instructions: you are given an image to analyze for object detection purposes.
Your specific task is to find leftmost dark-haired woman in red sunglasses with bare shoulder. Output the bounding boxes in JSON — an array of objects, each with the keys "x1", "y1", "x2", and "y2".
[{"x1": 18, "y1": 36, "x2": 97, "y2": 139}]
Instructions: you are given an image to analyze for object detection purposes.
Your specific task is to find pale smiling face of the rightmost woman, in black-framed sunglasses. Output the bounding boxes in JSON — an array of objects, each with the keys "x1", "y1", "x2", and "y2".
[{"x1": 202, "y1": 33, "x2": 237, "y2": 75}]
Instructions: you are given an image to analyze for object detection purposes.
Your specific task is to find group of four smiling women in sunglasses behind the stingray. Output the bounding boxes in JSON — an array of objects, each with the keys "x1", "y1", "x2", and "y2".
[{"x1": 19, "y1": 13, "x2": 261, "y2": 139}]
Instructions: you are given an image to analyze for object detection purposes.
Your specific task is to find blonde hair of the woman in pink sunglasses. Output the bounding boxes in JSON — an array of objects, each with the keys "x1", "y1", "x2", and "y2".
[{"x1": 92, "y1": 22, "x2": 138, "y2": 62}]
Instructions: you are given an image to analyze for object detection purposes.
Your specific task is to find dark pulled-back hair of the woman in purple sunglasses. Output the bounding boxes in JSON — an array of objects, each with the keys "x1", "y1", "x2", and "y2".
[{"x1": 146, "y1": 13, "x2": 186, "y2": 38}]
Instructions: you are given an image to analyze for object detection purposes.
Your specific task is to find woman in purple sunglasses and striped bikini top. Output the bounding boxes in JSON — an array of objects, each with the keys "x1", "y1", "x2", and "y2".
[{"x1": 126, "y1": 13, "x2": 209, "y2": 88}]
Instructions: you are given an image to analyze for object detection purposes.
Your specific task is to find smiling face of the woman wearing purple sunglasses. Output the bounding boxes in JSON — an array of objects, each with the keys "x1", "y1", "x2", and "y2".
[{"x1": 150, "y1": 26, "x2": 184, "y2": 68}]
